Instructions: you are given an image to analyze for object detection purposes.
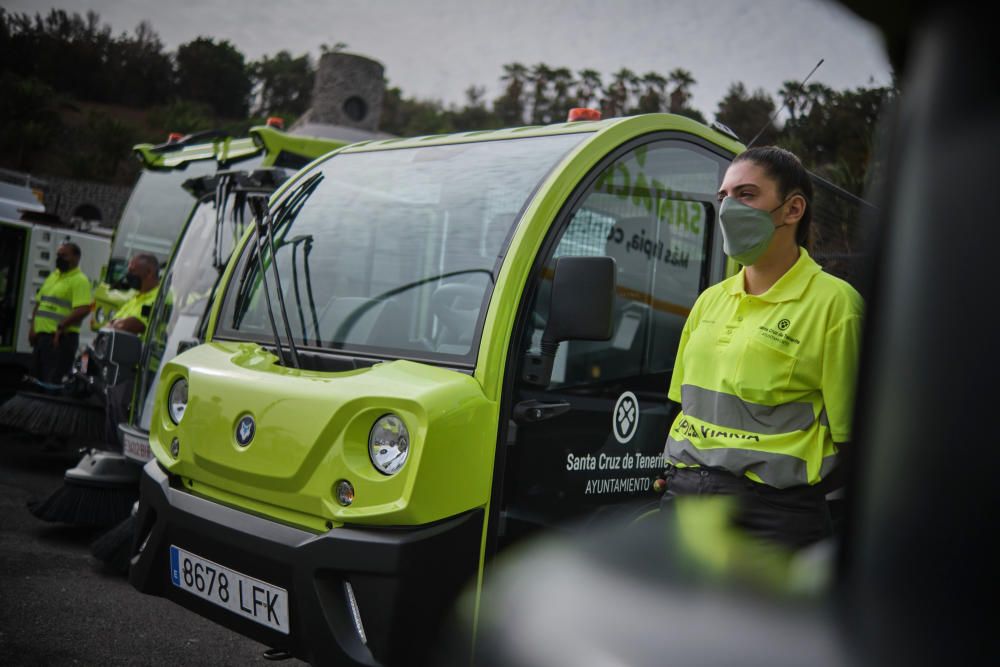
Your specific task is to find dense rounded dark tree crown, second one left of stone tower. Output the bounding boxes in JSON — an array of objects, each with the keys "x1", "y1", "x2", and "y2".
[{"x1": 177, "y1": 37, "x2": 253, "y2": 118}]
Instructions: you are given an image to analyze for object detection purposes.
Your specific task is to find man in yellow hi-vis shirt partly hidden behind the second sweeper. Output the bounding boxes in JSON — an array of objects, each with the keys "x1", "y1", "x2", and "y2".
[{"x1": 104, "y1": 253, "x2": 160, "y2": 452}]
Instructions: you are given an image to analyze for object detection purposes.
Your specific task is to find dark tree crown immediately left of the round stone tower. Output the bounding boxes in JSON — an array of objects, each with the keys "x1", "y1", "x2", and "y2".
[{"x1": 250, "y1": 51, "x2": 316, "y2": 116}]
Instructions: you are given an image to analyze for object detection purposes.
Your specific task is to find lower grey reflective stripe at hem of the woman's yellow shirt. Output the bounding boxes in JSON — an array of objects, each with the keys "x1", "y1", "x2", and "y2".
[{"x1": 665, "y1": 436, "x2": 809, "y2": 489}]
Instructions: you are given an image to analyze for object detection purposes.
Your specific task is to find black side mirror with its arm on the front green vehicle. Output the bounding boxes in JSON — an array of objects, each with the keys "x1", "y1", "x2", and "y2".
[{"x1": 522, "y1": 257, "x2": 616, "y2": 387}]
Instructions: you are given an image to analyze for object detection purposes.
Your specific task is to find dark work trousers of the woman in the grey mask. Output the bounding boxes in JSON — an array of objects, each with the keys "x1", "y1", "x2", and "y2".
[{"x1": 661, "y1": 467, "x2": 833, "y2": 549}]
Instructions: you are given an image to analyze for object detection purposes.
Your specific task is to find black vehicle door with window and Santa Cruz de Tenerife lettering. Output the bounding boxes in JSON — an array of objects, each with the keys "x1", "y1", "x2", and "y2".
[{"x1": 494, "y1": 134, "x2": 729, "y2": 546}]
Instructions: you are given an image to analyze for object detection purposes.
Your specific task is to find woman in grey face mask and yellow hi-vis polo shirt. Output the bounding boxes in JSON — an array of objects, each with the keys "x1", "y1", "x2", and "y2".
[{"x1": 664, "y1": 147, "x2": 862, "y2": 547}]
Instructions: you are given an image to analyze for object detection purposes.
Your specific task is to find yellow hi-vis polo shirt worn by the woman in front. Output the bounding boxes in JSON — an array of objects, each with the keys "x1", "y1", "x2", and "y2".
[{"x1": 664, "y1": 249, "x2": 863, "y2": 488}]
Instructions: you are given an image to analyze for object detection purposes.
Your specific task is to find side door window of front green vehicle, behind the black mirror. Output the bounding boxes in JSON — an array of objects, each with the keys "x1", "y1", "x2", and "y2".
[{"x1": 531, "y1": 141, "x2": 721, "y2": 387}]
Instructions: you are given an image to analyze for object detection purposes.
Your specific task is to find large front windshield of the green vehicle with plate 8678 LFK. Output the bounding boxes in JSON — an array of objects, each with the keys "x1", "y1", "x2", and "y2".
[{"x1": 217, "y1": 133, "x2": 588, "y2": 364}]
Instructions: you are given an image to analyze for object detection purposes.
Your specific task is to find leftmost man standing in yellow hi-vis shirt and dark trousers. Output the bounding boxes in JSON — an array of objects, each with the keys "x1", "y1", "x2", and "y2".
[{"x1": 28, "y1": 242, "x2": 91, "y2": 383}]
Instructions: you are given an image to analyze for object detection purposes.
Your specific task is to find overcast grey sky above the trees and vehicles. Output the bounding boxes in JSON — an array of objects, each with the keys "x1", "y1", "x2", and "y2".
[{"x1": 0, "y1": 0, "x2": 890, "y2": 120}]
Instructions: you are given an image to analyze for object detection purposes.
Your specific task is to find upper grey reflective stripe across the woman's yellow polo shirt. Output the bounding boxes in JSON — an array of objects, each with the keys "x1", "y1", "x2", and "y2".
[{"x1": 681, "y1": 384, "x2": 814, "y2": 435}]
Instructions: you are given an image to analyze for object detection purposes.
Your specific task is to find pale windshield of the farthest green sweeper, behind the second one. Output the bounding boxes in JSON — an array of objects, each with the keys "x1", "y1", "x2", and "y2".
[{"x1": 105, "y1": 160, "x2": 243, "y2": 285}]
